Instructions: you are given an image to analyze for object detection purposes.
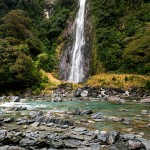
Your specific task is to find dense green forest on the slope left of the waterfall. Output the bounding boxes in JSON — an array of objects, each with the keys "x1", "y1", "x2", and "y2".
[{"x1": 0, "y1": 0, "x2": 76, "y2": 89}]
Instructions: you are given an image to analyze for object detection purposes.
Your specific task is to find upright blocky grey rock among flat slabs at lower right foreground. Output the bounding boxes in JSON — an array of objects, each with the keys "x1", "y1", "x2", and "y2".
[{"x1": 108, "y1": 131, "x2": 120, "y2": 144}]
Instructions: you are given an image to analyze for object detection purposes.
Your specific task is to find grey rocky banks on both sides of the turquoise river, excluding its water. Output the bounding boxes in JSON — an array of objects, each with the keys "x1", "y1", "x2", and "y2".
[{"x1": 0, "y1": 86, "x2": 150, "y2": 150}]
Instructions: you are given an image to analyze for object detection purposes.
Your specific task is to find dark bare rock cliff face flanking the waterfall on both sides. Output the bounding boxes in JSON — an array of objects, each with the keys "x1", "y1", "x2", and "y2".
[{"x1": 59, "y1": 1, "x2": 92, "y2": 81}]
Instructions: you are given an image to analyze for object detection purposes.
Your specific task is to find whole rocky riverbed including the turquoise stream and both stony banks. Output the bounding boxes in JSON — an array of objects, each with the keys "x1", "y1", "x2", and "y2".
[{"x1": 0, "y1": 84, "x2": 150, "y2": 150}]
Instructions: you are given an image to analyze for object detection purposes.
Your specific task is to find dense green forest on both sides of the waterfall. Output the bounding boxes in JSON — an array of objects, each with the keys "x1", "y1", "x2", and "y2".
[{"x1": 0, "y1": 0, "x2": 150, "y2": 89}]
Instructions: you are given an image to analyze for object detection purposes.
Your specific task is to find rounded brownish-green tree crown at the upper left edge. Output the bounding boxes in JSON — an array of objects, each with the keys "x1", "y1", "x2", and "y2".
[{"x1": 0, "y1": 10, "x2": 31, "y2": 40}]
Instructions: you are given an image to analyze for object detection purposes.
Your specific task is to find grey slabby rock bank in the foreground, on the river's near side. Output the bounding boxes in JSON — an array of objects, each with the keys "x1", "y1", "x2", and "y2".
[{"x1": 0, "y1": 111, "x2": 150, "y2": 150}]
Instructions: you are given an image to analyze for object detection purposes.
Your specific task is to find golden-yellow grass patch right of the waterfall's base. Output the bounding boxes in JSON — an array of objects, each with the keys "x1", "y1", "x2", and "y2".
[{"x1": 86, "y1": 73, "x2": 150, "y2": 89}]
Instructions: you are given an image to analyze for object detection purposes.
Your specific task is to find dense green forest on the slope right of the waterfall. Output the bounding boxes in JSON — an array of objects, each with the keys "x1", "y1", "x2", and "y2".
[{"x1": 90, "y1": 0, "x2": 150, "y2": 75}]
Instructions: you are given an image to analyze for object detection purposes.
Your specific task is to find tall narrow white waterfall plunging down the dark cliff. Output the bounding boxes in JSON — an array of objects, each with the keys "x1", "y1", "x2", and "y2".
[{"x1": 69, "y1": 0, "x2": 86, "y2": 83}]
